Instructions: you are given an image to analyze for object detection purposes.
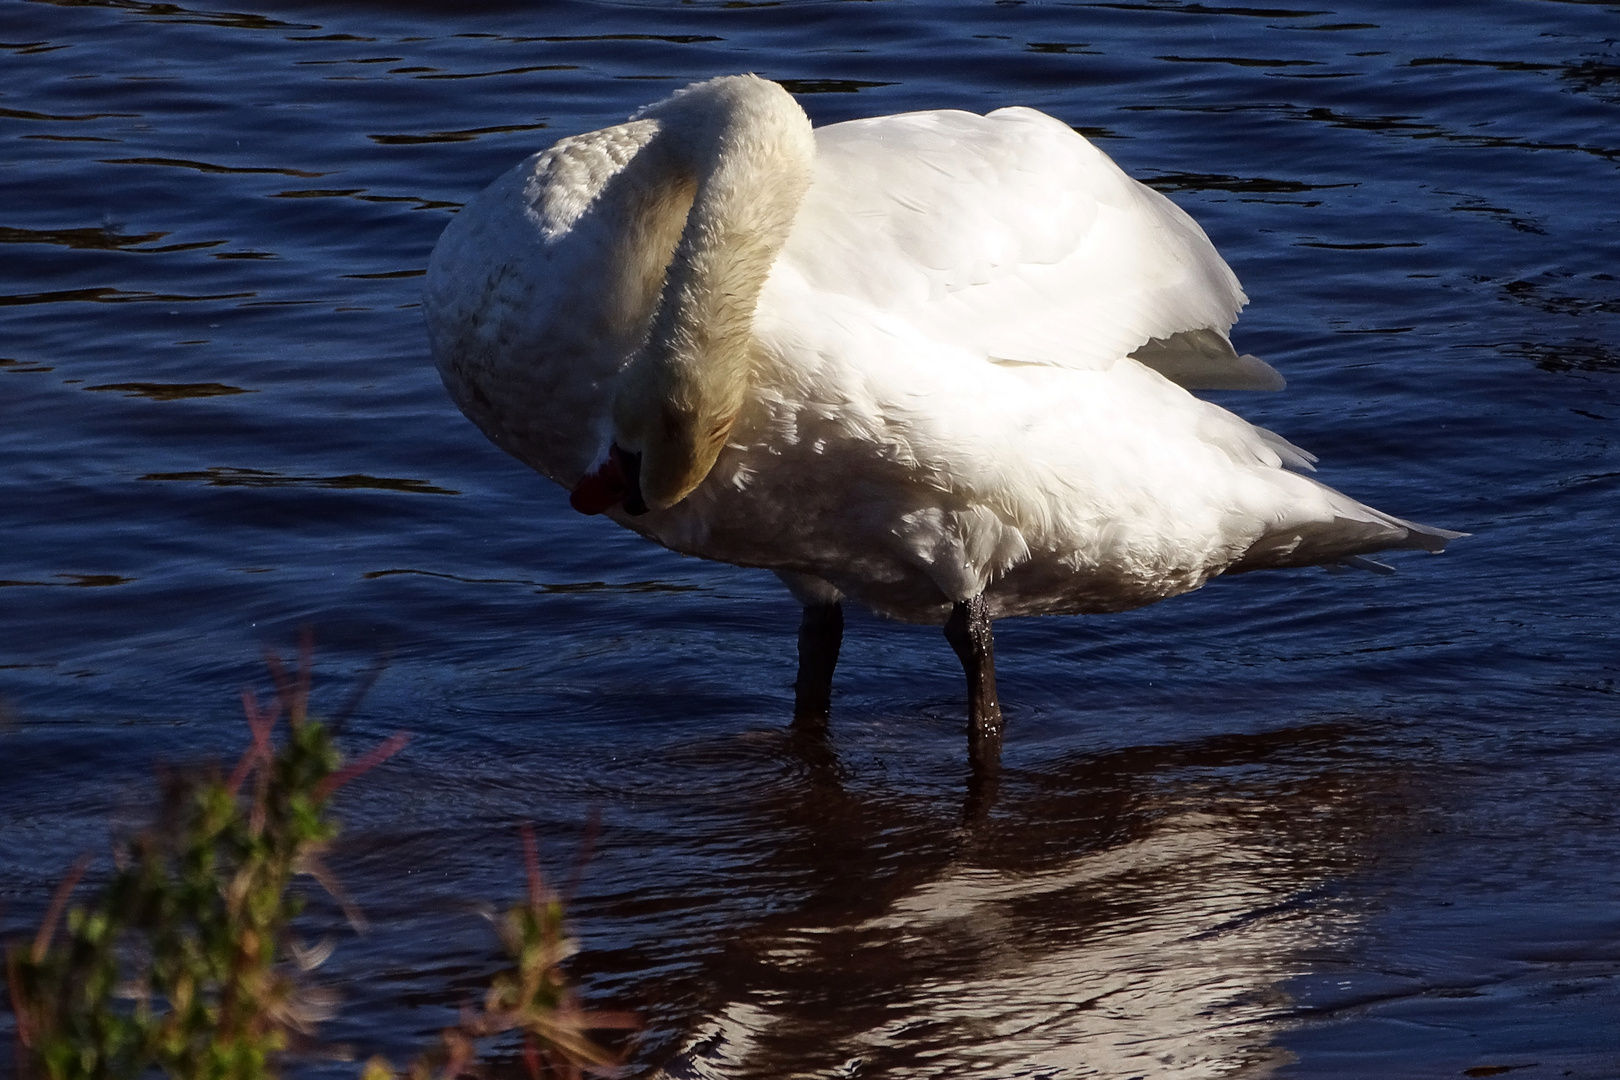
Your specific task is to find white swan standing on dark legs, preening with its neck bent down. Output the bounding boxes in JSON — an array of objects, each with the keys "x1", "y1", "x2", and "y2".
[{"x1": 423, "y1": 74, "x2": 1463, "y2": 772}]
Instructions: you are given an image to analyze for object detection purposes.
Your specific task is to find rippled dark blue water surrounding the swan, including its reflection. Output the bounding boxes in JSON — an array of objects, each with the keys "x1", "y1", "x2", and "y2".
[{"x1": 0, "y1": 0, "x2": 1620, "y2": 1077}]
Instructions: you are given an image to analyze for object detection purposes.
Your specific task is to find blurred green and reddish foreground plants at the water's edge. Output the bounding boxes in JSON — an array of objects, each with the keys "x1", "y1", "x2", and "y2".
[{"x1": 6, "y1": 641, "x2": 637, "y2": 1080}]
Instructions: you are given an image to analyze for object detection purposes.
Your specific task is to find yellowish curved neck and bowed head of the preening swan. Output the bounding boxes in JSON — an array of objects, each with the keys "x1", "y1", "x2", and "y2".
[{"x1": 614, "y1": 76, "x2": 815, "y2": 508}]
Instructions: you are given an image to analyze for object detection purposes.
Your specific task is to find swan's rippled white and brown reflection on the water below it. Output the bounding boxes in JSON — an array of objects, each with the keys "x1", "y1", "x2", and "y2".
[{"x1": 644, "y1": 727, "x2": 1382, "y2": 1078}]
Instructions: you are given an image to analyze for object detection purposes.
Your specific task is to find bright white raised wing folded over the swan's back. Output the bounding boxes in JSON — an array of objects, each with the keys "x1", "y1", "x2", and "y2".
[{"x1": 779, "y1": 108, "x2": 1281, "y2": 389}]
